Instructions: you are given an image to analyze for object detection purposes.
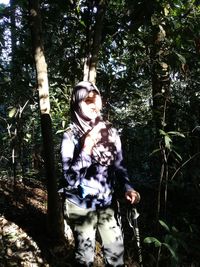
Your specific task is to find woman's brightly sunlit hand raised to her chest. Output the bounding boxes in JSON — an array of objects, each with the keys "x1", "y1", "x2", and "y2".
[{"x1": 83, "y1": 121, "x2": 106, "y2": 155}]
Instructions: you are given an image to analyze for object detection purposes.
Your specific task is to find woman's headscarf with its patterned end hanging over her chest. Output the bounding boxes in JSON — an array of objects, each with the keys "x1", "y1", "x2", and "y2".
[{"x1": 70, "y1": 81, "x2": 117, "y2": 165}]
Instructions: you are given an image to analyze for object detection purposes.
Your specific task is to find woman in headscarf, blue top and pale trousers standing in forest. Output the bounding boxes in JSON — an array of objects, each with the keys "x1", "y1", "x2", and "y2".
[{"x1": 61, "y1": 81, "x2": 139, "y2": 266}]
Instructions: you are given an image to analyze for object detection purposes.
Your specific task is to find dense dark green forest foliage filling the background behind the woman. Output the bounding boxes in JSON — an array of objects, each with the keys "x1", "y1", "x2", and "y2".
[{"x1": 0, "y1": 0, "x2": 200, "y2": 266}]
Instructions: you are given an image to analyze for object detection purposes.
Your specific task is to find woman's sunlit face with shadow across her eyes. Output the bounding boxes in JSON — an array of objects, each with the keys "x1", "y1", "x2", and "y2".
[{"x1": 81, "y1": 91, "x2": 102, "y2": 120}]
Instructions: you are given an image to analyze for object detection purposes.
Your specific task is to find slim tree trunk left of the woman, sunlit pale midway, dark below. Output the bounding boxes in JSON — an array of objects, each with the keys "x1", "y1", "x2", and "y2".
[{"x1": 29, "y1": 0, "x2": 63, "y2": 238}]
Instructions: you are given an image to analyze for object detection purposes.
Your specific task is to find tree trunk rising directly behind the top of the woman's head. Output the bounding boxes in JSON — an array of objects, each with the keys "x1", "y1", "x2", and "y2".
[{"x1": 83, "y1": 0, "x2": 106, "y2": 84}]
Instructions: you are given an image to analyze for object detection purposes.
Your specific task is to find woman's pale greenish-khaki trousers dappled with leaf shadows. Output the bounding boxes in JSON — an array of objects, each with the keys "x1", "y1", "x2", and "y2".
[{"x1": 65, "y1": 200, "x2": 124, "y2": 267}]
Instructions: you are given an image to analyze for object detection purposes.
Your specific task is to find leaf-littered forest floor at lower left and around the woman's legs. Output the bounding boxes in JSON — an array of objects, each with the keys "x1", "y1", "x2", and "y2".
[{"x1": 0, "y1": 176, "x2": 139, "y2": 267}]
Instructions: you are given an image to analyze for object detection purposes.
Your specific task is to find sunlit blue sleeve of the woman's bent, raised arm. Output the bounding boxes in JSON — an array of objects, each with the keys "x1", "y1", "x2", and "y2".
[{"x1": 61, "y1": 132, "x2": 91, "y2": 187}]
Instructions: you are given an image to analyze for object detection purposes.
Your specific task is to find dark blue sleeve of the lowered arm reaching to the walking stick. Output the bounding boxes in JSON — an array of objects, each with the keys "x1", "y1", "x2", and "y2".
[{"x1": 114, "y1": 130, "x2": 134, "y2": 192}]
